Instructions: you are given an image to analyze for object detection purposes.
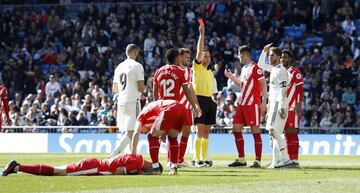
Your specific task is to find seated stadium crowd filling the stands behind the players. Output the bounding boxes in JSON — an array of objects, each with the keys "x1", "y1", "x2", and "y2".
[{"x1": 0, "y1": 0, "x2": 360, "y2": 132}]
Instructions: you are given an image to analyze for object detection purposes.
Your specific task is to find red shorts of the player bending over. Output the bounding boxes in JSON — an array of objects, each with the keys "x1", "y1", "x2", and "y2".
[{"x1": 151, "y1": 103, "x2": 186, "y2": 132}]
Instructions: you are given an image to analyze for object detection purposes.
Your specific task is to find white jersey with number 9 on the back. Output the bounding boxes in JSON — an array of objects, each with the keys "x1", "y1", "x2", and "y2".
[{"x1": 114, "y1": 59, "x2": 144, "y2": 104}]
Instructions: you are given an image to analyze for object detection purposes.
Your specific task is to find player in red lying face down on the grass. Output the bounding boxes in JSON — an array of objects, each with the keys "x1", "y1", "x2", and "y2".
[{"x1": 2, "y1": 154, "x2": 162, "y2": 176}]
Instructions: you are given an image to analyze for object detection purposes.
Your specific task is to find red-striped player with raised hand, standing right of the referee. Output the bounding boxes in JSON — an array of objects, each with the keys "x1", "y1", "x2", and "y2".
[{"x1": 225, "y1": 45, "x2": 267, "y2": 168}]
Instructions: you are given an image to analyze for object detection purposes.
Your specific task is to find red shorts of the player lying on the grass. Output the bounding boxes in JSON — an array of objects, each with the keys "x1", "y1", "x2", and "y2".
[{"x1": 66, "y1": 158, "x2": 112, "y2": 176}]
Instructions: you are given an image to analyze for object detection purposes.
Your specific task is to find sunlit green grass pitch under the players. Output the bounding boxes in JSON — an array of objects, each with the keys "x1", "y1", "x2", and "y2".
[{"x1": 0, "y1": 154, "x2": 360, "y2": 193}]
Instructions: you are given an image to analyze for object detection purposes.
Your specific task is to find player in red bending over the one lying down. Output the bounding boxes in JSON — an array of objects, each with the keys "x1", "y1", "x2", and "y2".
[{"x1": 132, "y1": 100, "x2": 186, "y2": 175}]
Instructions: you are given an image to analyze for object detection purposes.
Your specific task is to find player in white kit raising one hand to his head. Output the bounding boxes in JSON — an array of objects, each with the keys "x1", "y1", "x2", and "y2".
[{"x1": 258, "y1": 44, "x2": 292, "y2": 168}]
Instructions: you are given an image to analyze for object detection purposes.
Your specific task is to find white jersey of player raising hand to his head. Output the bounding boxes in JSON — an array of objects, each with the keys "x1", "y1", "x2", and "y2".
[{"x1": 258, "y1": 53, "x2": 290, "y2": 108}]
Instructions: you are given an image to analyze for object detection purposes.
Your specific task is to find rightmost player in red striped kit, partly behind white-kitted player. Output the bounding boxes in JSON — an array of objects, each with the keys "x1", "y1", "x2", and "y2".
[{"x1": 281, "y1": 49, "x2": 304, "y2": 167}]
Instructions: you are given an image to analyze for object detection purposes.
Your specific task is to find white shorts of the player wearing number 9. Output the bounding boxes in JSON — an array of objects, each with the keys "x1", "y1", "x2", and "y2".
[{"x1": 116, "y1": 101, "x2": 140, "y2": 131}]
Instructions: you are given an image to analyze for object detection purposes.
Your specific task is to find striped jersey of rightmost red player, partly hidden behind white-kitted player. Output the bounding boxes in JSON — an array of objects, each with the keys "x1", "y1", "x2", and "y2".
[{"x1": 287, "y1": 66, "x2": 304, "y2": 110}]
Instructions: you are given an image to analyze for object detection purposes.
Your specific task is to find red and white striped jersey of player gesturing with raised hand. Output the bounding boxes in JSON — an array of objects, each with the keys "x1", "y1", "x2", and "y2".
[{"x1": 239, "y1": 62, "x2": 265, "y2": 105}]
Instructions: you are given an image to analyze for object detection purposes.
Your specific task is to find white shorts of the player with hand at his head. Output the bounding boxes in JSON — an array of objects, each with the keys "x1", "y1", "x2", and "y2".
[{"x1": 265, "y1": 101, "x2": 287, "y2": 134}]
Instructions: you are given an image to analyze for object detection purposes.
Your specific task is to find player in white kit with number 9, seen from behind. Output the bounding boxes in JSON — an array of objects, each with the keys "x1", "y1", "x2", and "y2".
[{"x1": 110, "y1": 44, "x2": 145, "y2": 158}]
